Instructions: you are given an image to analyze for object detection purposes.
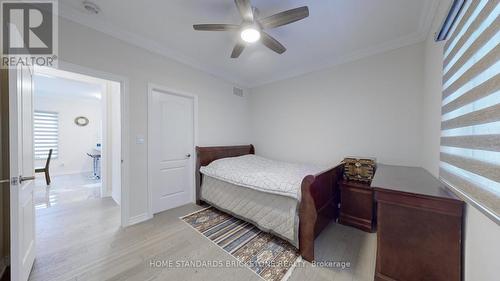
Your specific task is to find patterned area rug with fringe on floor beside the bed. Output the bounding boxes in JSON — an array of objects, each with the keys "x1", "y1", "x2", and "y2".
[{"x1": 181, "y1": 207, "x2": 300, "y2": 281}]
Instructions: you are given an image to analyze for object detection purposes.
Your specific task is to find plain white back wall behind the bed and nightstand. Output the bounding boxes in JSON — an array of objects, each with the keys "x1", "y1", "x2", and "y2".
[{"x1": 250, "y1": 44, "x2": 424, "y2": 166}]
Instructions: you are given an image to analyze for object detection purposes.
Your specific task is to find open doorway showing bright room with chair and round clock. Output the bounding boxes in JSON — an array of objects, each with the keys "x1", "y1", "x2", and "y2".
[{"x1": 30, "y1": 68, "x2": 122, "y2": 280}]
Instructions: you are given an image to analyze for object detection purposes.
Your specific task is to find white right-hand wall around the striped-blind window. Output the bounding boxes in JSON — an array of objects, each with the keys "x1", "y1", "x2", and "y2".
[{"x1": 422, "y1": 0, "x2": 500, "y2": 281}]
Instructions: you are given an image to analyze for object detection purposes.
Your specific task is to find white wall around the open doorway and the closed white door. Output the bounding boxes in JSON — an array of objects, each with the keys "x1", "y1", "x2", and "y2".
[{"x1": 59, "y1": 19, "x2": 250, "y2": 220}]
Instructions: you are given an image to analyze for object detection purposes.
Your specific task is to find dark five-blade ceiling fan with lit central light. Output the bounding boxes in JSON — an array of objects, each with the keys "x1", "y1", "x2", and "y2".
[{"x1": 193, "y1": 0, "x2": 309, "y2": 59}]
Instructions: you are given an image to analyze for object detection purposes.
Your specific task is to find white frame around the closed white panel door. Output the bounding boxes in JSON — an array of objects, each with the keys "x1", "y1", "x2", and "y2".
[{"x1": 147, "y1": 83, "x2": 198, "y2": 218}]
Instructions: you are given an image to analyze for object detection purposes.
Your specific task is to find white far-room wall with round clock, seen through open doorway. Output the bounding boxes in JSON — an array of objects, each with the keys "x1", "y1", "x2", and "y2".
[{"x1": 35, "y1": 96, "x2": 101, "y2": 177}]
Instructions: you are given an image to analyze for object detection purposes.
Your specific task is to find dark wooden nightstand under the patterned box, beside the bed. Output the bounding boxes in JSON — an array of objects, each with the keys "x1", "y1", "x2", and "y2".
[{"x1": 339, "y1": 180, "x2": 375, "y2": 232}]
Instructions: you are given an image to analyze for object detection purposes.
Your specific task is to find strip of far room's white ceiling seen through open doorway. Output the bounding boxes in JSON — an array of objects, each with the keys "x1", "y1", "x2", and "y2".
[{"x1": 34, "y1": 73, "x2": 102, "y2": 100}]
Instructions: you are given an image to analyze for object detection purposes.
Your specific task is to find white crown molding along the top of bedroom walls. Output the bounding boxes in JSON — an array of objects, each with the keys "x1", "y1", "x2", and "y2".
[{"x1": 59, "y1": 0, "x2": 439, "y2": 89}]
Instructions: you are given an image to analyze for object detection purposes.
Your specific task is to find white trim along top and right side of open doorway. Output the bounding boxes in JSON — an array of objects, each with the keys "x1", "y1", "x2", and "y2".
[{"x1": 41, "y1": 60, "x2": 131, "y2": 227}]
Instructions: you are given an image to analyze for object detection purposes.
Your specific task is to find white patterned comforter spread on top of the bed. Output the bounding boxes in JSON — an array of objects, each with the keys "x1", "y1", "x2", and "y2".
[{"x1": 200, "y1": 154, "x2": 326, "y2": 200}]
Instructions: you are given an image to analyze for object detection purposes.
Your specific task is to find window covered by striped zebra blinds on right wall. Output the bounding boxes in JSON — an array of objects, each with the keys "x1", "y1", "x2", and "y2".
[{"x1": 440, "y1": 0, "x2": 500, "y2": 219}]
